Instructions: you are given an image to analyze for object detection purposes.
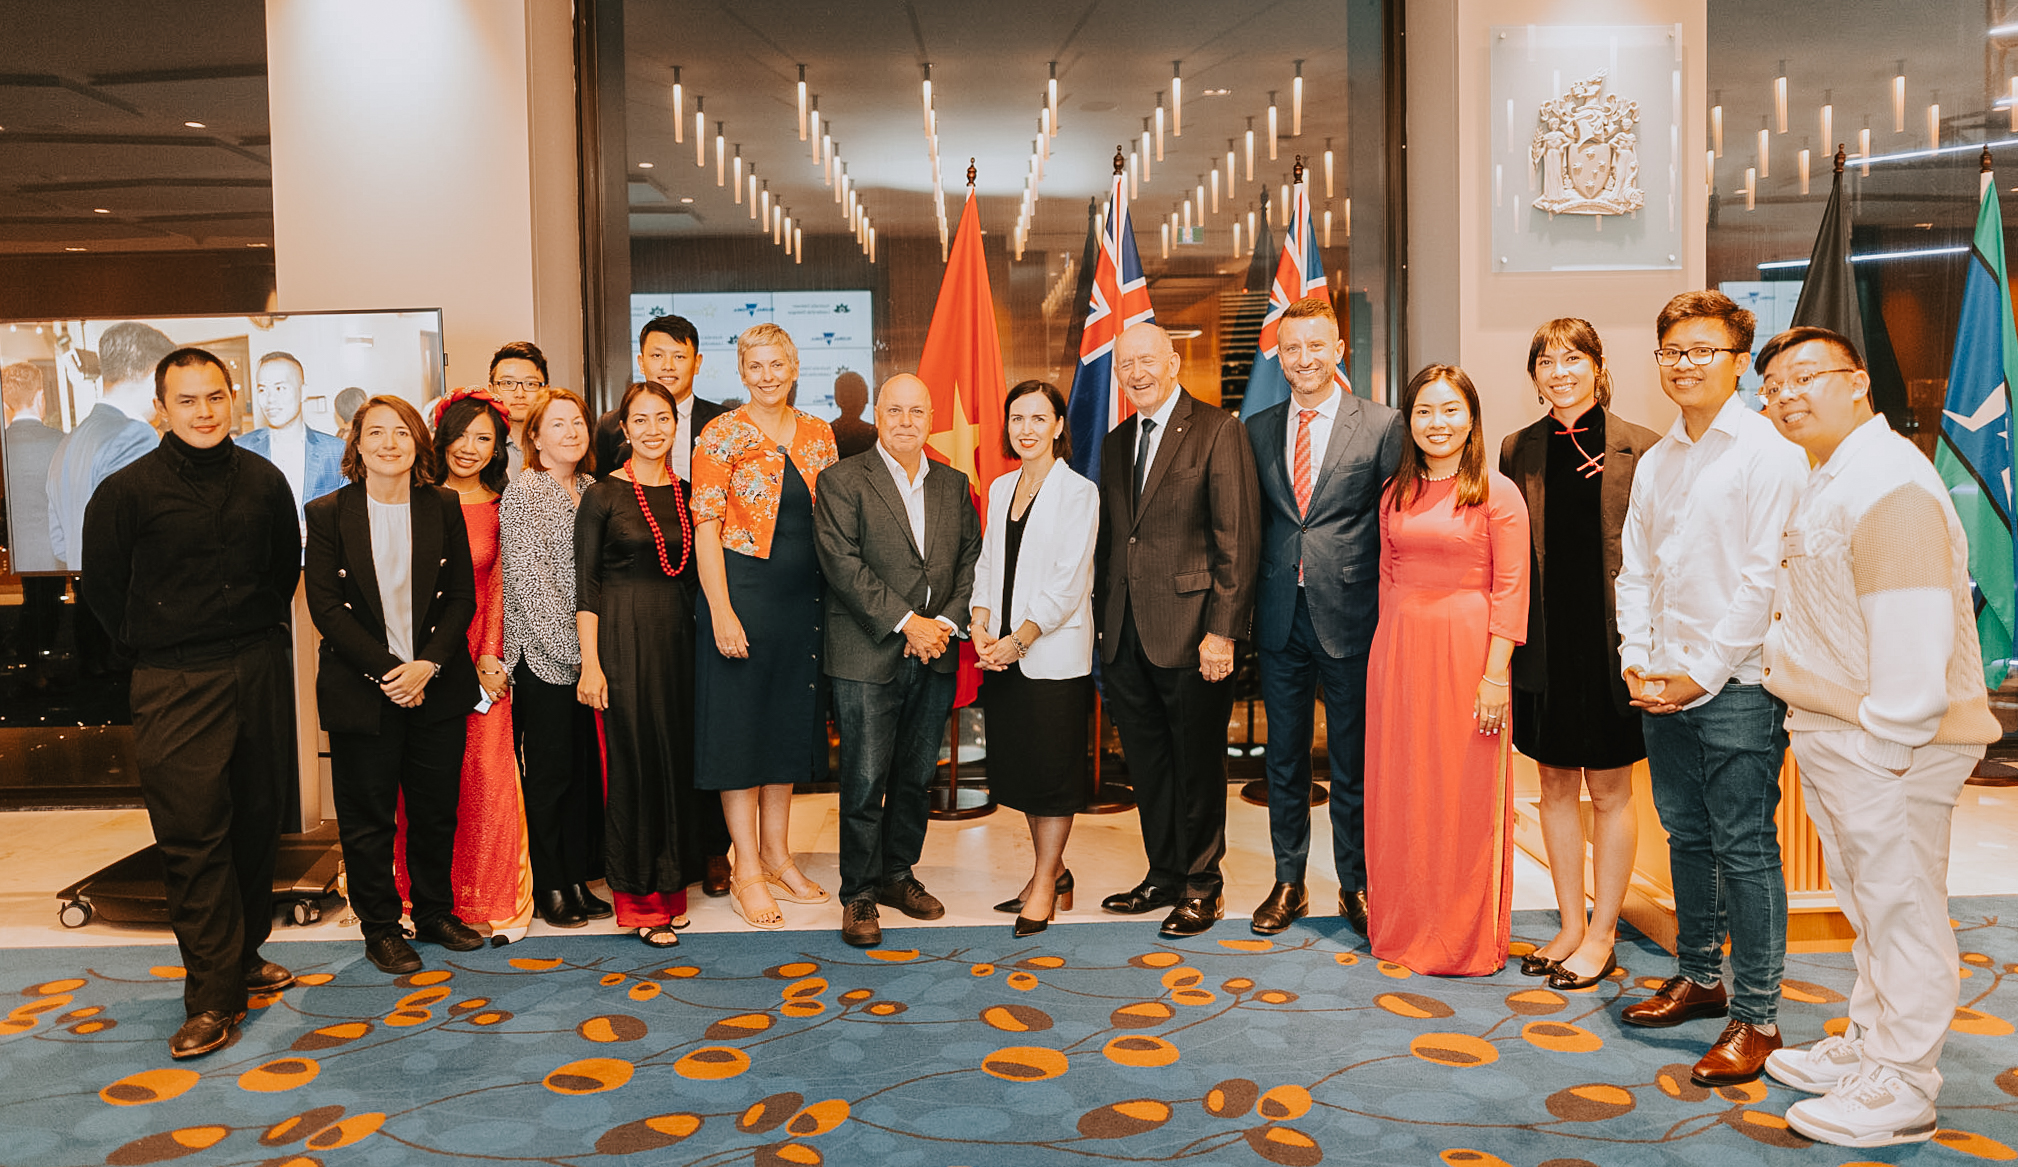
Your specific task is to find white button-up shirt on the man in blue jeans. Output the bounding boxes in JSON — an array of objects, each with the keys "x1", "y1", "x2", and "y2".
[{"x1": 1616, "y1": 394, "x2": 1808, "y2": 709}]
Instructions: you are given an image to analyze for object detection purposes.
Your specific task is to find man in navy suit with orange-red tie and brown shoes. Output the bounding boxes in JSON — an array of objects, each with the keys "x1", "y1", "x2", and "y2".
[{"x1": 1247, "y1": 297, "x2": 1407, "y2": 935}]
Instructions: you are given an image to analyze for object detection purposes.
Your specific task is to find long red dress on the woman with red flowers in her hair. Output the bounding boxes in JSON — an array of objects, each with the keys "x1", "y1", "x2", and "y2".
[{"x1": 394, "y1": 499, "x2": 533, "y2": 939}]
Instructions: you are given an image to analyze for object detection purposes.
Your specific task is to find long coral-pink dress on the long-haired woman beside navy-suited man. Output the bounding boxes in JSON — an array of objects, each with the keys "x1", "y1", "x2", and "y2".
[{"x1": 1366, "y1": 472, "x2": 1528, "y2": 975}]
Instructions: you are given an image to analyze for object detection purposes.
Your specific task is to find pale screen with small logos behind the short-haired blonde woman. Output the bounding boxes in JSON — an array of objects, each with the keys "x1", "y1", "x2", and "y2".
[{"x1": 630, "y1": 291, "x2": 876, "y2": 422}]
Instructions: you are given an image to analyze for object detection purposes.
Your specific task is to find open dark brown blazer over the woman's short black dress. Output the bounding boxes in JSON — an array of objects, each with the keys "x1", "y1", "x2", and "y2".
[{"x1": 1499, "y1": 410, "x2": 1661, "y2": 713}]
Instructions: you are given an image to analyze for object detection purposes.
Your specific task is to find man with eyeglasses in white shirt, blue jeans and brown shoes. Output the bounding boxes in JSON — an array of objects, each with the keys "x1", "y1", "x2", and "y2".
[{"x1": 1616, "y1": 291, "x2": 1806, "y2": 1086}]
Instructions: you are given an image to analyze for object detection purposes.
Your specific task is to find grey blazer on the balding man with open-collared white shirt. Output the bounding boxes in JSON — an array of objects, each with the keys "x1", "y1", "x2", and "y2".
[{"x1": 813, "y1": 446, "x2": 981, "y2": 684}]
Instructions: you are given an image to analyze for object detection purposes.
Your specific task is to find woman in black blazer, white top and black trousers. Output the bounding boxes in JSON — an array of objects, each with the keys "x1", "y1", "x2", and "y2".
[{"x1": 303, "y1": 396, "x2": 484, "y2": 973}]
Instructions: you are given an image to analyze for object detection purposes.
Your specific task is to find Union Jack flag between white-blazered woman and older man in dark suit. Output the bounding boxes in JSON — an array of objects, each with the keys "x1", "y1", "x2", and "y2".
[{"x1": 1066, "y1": 165, "x2": 1156, "y2": 483}]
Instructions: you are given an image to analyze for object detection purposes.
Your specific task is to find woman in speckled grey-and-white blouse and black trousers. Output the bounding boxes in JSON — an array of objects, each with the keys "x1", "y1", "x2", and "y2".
[{"x1": 498, "y1": 390, "x2": 609, "y2": 929}]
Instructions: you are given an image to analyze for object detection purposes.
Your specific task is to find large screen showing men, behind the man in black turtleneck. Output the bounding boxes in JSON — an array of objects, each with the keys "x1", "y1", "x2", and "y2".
[{"x1": 0, "y1": 309, "x2": 446, "y2": 575}]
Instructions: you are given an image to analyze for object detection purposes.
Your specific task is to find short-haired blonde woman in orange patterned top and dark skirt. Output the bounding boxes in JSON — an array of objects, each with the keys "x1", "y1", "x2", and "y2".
[{"x1": 694, "y1": 323, "x2": 837, "y2": 929}]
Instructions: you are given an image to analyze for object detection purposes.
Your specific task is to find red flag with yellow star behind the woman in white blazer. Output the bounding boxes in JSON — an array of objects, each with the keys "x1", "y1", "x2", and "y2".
[{"x1": 918, "y1": 186, "x2": 1015, "y2": 707}]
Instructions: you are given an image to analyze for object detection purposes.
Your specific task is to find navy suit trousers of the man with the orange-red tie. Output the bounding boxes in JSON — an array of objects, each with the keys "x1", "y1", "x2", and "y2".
[{"x1": 1259, "y1": 588, "x2": 1368, "y2": 880}]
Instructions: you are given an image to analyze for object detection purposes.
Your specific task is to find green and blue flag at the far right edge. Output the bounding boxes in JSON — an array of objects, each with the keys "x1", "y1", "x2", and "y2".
[{"x1": 1933, "y1": 176, "x2": 2018, "y2": 688}]
